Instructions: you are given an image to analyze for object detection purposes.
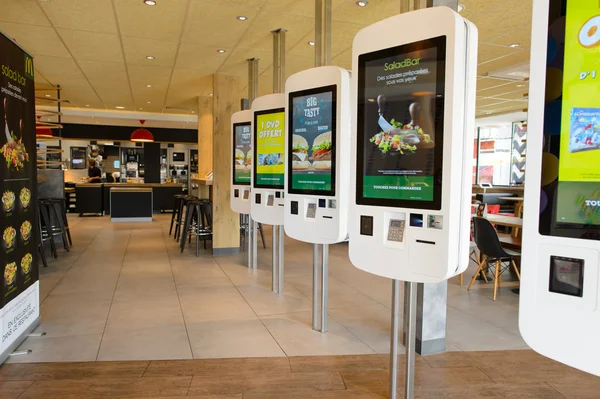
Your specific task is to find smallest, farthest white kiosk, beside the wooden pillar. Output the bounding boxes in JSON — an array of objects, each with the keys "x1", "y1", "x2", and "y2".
[{"x1": 231, "y1": 110, "x2": 253, "y2": 214}]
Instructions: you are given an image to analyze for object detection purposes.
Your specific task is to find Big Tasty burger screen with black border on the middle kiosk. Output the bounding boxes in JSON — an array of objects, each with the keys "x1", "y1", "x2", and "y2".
[{"x1": 288, "y1": 85, "x2": 337, "y2": 196}]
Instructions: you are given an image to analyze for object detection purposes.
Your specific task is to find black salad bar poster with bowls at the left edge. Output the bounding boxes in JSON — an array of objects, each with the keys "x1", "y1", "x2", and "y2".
[{"x1": 0, "y1": 35, "x2": 38, "y2": 310}]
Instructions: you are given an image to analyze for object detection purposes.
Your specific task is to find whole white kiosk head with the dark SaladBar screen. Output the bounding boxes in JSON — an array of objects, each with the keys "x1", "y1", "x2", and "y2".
[{"x1": 349, "y1": 7, "x2": 477, "y2": 283}]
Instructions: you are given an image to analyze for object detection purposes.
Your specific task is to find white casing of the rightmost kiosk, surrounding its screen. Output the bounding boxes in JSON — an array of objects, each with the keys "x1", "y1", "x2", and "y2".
[{"x1": 519, "y1": 0, "x2": 600, "y2": 376}]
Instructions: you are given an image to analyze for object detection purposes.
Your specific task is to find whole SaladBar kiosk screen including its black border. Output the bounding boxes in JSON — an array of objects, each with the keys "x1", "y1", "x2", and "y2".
[{"x1": 356, "y1": 36, "x2": 446, "y2": 210}]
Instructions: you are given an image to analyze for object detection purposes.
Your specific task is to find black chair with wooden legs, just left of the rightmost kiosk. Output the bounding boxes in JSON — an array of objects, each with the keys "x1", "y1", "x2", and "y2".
[{"x1": 468, "y1": 216, "x2": 521, "y2": 301}]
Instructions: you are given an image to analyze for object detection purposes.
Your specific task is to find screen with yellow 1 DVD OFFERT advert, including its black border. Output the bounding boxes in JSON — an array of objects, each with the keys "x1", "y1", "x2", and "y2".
[{"x1": 254, "y1": 108, "x2": 285, "y2": 190}]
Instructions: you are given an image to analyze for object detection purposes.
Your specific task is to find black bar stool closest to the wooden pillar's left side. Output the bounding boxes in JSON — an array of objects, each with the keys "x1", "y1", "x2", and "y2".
[{"x1": 180, "y1": 199, "x2": 212, "y2": 256}]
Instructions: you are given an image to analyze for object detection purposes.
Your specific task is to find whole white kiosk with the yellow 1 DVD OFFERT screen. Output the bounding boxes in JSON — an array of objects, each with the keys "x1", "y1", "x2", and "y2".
[{"x1": 250, "y1": 93, "x2": 285, "y2": 225}]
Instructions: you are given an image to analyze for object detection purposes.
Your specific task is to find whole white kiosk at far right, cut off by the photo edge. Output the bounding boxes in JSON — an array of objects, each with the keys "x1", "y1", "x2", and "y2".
[{"x1": 519, "y1": 0, "x2": 600, "y2": 375}]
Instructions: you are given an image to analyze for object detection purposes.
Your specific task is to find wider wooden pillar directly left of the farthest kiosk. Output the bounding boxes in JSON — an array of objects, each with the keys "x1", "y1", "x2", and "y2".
[{"x1": 212, "y1": 74, "x2": 240, "y2": 255}]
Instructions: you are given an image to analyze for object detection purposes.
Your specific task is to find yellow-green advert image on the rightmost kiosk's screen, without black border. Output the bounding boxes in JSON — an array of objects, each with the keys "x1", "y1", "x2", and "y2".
[{"x1": 546, "y1": 0, "x2": 600, "y2": 226}]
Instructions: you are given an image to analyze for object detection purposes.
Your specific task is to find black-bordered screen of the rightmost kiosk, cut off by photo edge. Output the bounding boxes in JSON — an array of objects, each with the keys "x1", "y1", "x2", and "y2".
[{"x1": 539, "y1": 0, "x2": 600, "y2": 240}]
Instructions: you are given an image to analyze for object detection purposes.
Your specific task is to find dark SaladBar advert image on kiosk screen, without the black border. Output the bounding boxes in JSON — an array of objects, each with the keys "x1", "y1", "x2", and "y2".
[{"x1": 358, "y1": 47, "x2": 440, "y2": 201}]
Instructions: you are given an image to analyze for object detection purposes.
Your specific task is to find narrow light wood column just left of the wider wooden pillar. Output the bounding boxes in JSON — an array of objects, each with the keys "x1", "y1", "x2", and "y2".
[{"x1": 197, "y1": 97, "x2": 213, "y2": 198}]
